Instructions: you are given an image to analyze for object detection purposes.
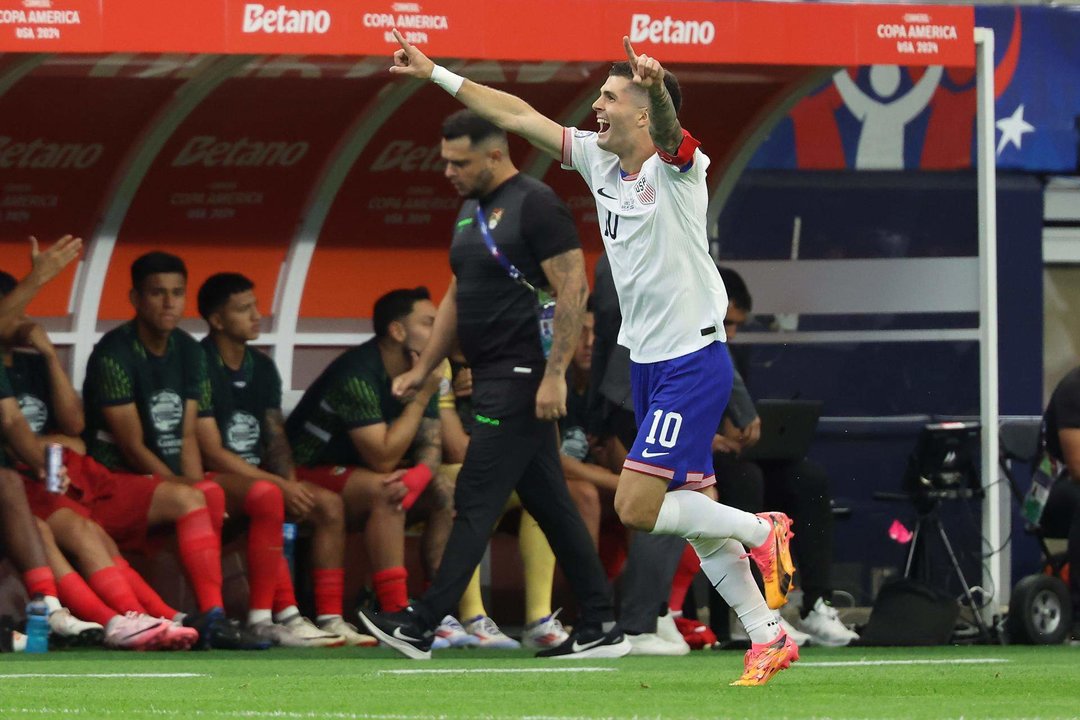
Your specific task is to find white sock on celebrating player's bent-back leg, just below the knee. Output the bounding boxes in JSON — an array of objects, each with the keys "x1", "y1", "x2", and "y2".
[{"x1": 652, "y1": 490, "x2": 771, "y2": 547}]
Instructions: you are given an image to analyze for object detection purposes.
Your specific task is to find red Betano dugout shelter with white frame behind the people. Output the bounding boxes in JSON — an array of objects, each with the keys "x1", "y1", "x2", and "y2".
[{"x1": 0, "y1": 0, "x2": 1010, "y2": 626}]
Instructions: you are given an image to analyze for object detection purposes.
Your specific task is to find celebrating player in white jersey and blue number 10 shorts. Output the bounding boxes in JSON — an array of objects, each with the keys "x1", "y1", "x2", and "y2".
[{"x1": 390, "y1": 35, "x2": 798, "y2": 685}]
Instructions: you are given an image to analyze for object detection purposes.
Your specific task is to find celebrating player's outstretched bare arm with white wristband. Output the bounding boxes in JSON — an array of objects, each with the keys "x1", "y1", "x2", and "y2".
[{"x1": 390, "y1": 29, "x2": 563, "y2": 160}]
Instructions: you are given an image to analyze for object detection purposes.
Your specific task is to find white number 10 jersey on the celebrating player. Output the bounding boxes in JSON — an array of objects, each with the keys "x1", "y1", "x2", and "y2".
[{"x1": 563, "y1": 127, "x2": 728, "y2": 363}]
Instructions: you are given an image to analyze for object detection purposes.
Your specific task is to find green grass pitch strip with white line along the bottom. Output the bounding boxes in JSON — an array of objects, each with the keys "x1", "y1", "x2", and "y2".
[{"x1": 0, "y1": 646, "x2": 1080, "y2": 720}]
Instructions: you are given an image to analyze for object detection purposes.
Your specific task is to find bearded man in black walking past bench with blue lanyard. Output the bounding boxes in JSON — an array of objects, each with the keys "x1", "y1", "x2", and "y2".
[{"x1": 361, "y1": 110, "x2": 630, "y2": 660}]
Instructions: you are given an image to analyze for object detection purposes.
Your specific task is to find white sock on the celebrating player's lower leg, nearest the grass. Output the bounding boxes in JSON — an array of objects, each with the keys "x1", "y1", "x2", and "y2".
[{"x1": 695, "y1": 535, "x2": 780, "y2": 643}]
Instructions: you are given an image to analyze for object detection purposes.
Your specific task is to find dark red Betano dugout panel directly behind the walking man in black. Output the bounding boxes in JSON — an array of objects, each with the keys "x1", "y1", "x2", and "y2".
[{"x1": 300, "y1": 63, "x2": 602, "y2": 317}]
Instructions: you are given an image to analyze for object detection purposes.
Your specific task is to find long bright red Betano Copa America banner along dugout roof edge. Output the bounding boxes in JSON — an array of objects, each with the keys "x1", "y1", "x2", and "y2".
[{"x1": 0, "y1": 0, "x2": 974, "y2": 67}]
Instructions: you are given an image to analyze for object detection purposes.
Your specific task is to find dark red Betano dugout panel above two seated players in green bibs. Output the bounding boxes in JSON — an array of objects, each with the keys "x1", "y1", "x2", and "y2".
[{"x1": 99, "y1": 77, "x2": 384, "y2": 320}]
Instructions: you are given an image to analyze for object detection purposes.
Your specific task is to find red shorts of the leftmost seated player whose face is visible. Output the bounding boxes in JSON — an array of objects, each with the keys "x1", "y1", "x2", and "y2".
[{"x1": 64, "y1": 452, "x2": 163, "y2": 552}]
